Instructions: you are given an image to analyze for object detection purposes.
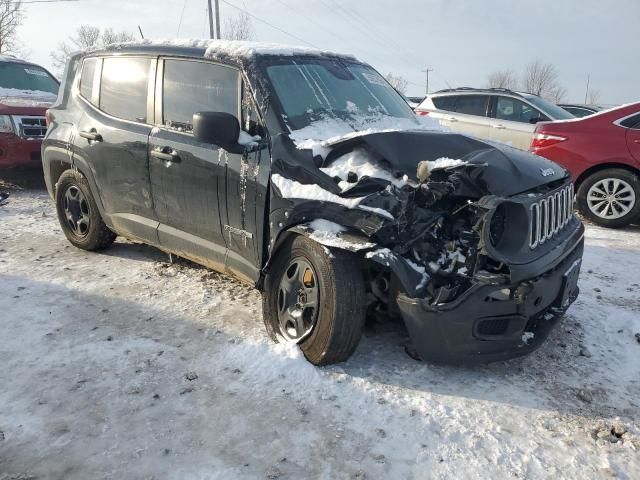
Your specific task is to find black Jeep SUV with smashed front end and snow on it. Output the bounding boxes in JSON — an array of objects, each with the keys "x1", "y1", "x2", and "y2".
[{"x1": 42, "y1": 41, "x2": 584, "y2": 365}]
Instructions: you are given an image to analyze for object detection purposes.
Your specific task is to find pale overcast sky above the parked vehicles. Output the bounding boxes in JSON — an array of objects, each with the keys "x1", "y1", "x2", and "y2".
[{"x1": 20, "y1": 0, "x2": 640, "y2": 104}]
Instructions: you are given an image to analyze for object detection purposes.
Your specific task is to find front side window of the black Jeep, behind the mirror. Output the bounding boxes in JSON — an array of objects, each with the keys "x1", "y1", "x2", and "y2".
[{"x1": 162, "y1": 60, "x2": 240, "y2": 132}]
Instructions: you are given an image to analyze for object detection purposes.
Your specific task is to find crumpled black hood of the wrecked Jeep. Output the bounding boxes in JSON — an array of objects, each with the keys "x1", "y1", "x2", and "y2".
[{"x1": 330, "y1": 130, "x2": 568, "y2": 196}]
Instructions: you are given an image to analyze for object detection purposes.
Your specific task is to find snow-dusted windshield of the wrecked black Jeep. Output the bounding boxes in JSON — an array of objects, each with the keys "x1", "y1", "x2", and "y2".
[{"x1": 266, "y1": 58, "x2": 419, "y2": 131}]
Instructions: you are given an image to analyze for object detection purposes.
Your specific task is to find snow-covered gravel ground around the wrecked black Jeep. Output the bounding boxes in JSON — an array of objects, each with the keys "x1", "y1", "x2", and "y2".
[{"x1": 0, "y1": 185, "x2": 640, "y2": 480}]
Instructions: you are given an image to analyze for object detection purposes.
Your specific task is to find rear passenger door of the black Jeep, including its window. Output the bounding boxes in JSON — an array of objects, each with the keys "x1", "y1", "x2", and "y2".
[{"x1": 72, "y1": 56, "x2": 158, "y2": 243}]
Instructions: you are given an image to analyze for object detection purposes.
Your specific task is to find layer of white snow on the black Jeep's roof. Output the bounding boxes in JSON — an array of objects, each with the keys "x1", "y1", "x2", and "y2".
[{"x1": 107, "y1": 39, "x2": 355, "y2": 60}]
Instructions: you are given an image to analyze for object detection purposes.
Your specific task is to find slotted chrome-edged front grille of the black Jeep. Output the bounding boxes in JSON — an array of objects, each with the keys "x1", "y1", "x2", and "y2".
[{"x1": 529, "y1": 183, "x2": 575, "y2": 250}]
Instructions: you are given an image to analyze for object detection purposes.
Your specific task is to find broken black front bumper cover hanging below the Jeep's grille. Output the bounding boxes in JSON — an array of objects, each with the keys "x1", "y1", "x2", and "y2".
[{"x1": 397, "y1": 225, "x2": 584, "y2": 364}]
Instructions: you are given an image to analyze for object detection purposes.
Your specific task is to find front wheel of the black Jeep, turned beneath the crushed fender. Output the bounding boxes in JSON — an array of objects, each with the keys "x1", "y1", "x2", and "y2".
[{"x1": 262, "y1": 236, "x2": 366, "y2": 365}]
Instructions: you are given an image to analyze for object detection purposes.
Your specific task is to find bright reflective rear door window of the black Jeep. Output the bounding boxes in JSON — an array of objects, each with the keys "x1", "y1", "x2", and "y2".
[{"x1": 100, "y1": 57, "x2": 151, "y2": 123}]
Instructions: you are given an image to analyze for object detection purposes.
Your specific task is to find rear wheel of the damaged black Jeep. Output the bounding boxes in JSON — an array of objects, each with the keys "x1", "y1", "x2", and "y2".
[{"x1": 56, "y1": 170, "x2": 116, "y2": 250}]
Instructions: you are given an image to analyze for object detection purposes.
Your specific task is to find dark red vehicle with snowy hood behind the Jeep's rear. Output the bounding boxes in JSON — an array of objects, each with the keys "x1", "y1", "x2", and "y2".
[{"x1": 0, "y1": 55, "x2": 59, "y2": 168}]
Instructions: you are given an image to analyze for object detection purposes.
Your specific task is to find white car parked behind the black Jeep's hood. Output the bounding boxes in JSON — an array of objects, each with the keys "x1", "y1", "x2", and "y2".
[{"x1": 415, "y1": 87, "x2": 575, "y2": 150}]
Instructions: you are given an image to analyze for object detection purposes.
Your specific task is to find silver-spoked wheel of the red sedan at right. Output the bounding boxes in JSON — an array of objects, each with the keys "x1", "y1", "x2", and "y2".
[{"x1": 577, "y1": 168, "x2": 640, "y2": 228}]
